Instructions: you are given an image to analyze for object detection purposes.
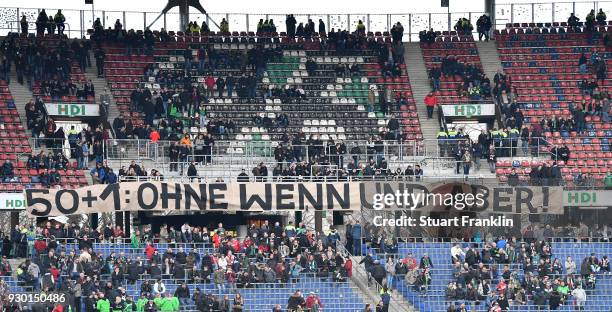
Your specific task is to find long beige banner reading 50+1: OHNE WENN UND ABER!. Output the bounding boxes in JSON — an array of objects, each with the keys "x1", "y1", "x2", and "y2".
[{"x1": 25, "y1": 182, "x2": 563, "y2": 217}]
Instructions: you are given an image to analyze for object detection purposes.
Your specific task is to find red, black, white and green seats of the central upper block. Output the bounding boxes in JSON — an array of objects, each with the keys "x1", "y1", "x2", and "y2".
[{"x1": 105, "y1": 34, "x2": 422, "y2": 141}]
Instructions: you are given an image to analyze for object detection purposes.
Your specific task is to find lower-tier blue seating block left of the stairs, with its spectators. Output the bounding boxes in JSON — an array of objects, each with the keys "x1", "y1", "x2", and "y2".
[{"x1": 3, "y1": 222, "x2": 364, "y2": 311}]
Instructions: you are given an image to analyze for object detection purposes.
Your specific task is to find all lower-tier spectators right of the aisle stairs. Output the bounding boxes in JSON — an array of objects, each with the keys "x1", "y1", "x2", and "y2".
[{"x1": 346, "y1": 222, "x2": 612, "y2": 312}]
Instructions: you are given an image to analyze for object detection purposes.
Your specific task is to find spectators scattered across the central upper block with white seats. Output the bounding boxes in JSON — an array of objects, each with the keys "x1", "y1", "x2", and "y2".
[{"x1": 88, "y1": 16, "x2": 414, "y2": 185}]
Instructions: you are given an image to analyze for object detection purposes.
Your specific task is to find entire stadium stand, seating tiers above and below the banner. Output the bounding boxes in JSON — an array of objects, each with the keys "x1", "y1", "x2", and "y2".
[{"x1": 0, "y1": 4, "x2": 612, "y2": 312}]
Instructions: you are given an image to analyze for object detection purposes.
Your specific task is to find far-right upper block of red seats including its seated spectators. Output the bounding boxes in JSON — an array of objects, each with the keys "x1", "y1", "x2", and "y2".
[{"x1": 496, "y1": 23, "x2": 612, "y2": 184}]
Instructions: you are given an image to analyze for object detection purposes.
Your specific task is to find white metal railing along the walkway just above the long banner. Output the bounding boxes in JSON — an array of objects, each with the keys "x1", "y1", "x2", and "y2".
[{"x1": 104, "y1": 137, "x2": 551, "y2": 166}]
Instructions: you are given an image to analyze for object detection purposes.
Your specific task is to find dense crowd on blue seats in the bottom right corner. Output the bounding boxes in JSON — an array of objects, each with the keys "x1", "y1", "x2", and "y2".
[{"x1": 446, "y1": 236, "x2": 610, "y2": 312}]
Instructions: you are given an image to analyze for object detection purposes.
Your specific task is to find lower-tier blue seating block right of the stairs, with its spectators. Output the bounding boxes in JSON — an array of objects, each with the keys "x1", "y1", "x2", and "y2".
[{"x1": 360, "y1": 237, "x2": 612, "y2": 311}]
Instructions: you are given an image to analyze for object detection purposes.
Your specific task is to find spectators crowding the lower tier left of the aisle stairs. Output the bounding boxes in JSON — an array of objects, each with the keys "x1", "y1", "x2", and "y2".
[{"x1": 1, "y1": 221, "x2": 366, "y2": 311}]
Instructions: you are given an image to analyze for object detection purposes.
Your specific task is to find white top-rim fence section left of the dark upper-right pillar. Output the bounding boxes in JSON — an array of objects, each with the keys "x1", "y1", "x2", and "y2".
[{"x1": 0, "y1": 7, "x2": 483, "y2": 41}]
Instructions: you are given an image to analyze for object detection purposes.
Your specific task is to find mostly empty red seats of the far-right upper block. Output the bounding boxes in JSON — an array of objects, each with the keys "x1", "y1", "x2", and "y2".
[{"x1": 496, "y1": 23, "x2": 612, "y2": 184}]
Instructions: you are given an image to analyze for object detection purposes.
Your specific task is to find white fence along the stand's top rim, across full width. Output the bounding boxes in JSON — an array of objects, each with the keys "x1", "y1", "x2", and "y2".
[{"x1": 0, "y1": 1, "x2": 612, "y2": 41}]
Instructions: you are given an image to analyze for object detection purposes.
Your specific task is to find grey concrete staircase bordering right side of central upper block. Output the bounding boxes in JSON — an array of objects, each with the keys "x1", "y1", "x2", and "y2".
[{"x1": 404, "y1": 42, "x2": 440, "y2": 154}]
